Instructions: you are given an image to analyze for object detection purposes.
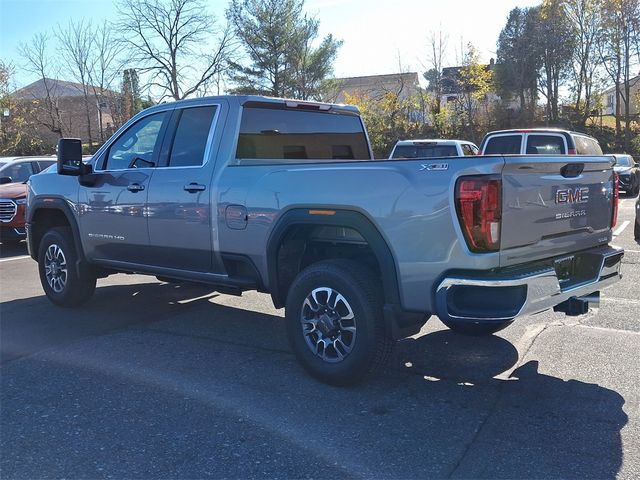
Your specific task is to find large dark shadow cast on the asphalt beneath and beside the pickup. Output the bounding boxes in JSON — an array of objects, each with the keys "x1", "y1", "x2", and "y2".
[{"x1": 2, "y1": 283, "x2": 627, "y2": 478}]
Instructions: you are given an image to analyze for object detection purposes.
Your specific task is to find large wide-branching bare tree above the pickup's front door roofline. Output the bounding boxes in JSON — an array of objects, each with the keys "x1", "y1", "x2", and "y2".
[{"x1": 117, "y1": 0, "x2": 232, "y2": 100}]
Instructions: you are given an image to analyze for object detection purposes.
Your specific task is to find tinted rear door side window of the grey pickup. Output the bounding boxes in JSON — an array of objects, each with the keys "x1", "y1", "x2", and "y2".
[{"x1": 169, "y1": 106, "x2": 216, "y2": 167}]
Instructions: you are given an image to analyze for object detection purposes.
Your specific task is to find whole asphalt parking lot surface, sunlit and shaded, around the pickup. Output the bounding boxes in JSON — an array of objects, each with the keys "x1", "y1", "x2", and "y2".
[{"x1": 0, "y1": 198, "x2": 640, "y2": 479}]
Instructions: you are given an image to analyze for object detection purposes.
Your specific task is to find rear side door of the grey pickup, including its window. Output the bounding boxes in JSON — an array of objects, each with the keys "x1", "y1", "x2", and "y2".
[{"x1": 148, "y1": 105, "x2": 220, "y2": 272}]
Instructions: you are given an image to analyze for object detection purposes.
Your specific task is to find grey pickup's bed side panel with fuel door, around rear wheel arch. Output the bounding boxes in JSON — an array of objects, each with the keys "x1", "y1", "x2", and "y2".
[{"x1": 217, "y1": 157, "x2": 503, "y2": 312}]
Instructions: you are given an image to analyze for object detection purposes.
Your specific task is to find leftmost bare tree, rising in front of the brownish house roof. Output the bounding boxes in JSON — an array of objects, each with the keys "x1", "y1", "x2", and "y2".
[{"x1": 18, "y1": 33, "x2": 71, "y2": 137}]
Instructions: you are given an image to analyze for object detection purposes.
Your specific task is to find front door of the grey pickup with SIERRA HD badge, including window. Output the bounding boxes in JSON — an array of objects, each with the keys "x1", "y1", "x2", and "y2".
[{"x1": 79, "y1": 111, "x2": 171, "y2": 264}]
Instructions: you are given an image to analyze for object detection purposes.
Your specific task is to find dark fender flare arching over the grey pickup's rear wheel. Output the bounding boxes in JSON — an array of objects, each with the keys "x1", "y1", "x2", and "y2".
[{"x1": 267, "y1": 207, "x2": 400, "y2": 308}]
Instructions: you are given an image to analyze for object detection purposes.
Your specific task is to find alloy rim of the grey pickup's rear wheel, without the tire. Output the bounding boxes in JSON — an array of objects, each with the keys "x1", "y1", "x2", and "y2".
[{"x1": 300, "y1": 287, "x2": 356, "y2": 363}]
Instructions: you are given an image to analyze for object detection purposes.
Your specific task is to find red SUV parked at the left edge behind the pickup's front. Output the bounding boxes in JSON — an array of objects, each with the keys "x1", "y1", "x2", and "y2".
[{"x1": 0, "y1": 157, "x2": 56, "y2": 245}]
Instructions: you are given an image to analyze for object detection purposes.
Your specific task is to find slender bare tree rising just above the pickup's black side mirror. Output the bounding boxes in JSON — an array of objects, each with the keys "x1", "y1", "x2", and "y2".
[{"x1": 56, "y1": 19, "x2": 93, "y2": 149}]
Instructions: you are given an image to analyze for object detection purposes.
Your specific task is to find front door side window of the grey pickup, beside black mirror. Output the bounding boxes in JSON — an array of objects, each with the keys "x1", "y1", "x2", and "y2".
[{"x1": 104, "y1": 112, "x2": 167, "y2": 170}]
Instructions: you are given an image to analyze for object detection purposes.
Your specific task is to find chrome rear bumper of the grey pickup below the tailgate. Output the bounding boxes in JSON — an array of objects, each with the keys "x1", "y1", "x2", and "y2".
[{"x1": 435, "y1": 246, "x2": 624, "y2": 323}]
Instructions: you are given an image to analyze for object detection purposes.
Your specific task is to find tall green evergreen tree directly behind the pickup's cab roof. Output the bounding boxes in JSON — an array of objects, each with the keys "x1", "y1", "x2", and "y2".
[{"x1": 227, "y1": 0, "x2": 342, "y2": 99}]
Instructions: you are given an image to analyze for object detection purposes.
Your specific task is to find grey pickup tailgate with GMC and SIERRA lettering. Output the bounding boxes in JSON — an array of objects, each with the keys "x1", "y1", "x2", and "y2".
[{"x1": 500, "y1": 156, "x2": 614, "y2": 266}]
